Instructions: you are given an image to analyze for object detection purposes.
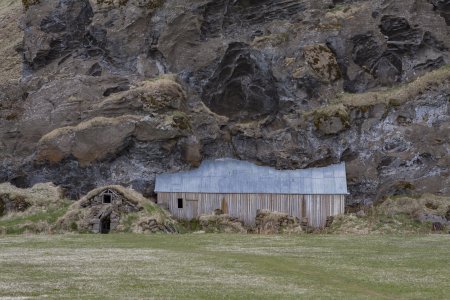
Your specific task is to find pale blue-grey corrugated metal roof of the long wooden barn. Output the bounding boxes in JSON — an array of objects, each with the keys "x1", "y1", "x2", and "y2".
[{"x1": 155, "y1": 158, "x2": 347, "y2": 195}]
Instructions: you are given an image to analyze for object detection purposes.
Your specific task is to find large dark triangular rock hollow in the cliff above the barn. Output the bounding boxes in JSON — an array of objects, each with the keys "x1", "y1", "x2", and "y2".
[{"x1": 203, "y1": 43, "x2": 279, "y2": 120}]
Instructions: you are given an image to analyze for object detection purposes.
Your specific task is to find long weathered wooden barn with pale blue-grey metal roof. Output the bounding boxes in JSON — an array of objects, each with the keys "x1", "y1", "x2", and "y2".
[{"x1": 155, "y1": 159, "x2": 348, "y2": 228}]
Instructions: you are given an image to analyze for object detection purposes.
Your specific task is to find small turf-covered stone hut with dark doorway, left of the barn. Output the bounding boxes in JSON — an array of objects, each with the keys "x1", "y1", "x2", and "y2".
[{"x1": 57, "y1": 185, "x2": 178, "y2": 233}]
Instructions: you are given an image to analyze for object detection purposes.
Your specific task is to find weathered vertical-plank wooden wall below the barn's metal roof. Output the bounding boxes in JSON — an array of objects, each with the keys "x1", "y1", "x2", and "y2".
[{"x1": 158, "y1": 193, "x2": 345, "y2": 228}]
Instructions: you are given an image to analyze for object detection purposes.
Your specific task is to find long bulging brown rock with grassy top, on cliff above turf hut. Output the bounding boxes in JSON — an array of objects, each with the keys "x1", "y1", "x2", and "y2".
[{"x1": 36, "y1": 115, "x2": 188, "y2": 165}]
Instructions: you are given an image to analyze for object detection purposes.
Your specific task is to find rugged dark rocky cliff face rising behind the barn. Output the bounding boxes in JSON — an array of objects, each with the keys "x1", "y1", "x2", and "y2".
[{"x1": 0, "y1": 0, "x2": 450, "y2": 202}]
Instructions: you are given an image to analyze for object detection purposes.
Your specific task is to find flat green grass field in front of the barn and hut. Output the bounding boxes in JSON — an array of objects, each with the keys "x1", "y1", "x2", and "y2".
[{"x1": 0, "y1": 234, "x2": 450, "y2": 299}]
